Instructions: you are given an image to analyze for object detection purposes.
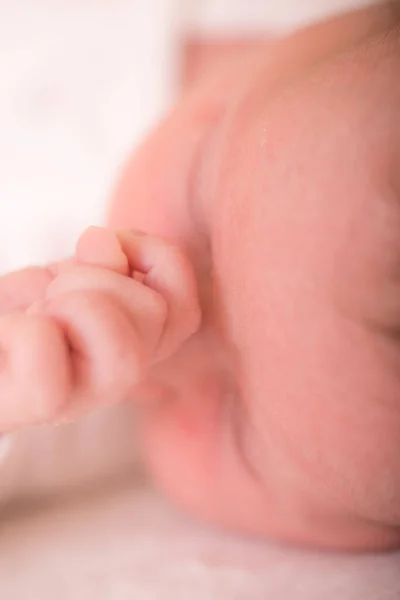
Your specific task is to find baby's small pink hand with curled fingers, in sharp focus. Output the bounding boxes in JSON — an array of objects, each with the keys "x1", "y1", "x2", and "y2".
[{"x1": 0, "y1": 228, "x2": 200, "y2": 432}]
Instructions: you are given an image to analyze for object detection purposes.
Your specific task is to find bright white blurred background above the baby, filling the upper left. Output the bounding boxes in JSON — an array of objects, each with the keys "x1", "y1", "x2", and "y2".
[{"x1": 0, "y1": 0, "x2": 366, "y2": 272}]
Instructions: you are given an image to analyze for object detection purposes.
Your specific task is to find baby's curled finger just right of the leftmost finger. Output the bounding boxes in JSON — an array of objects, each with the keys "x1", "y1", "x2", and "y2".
[{"x1": 45, "y1": 290, "x2": 145, "y2": 413}]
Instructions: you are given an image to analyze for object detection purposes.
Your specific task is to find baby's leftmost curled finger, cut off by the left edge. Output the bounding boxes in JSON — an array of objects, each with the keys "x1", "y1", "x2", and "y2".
[{"x1": 0, "y1": 313, "x2": 70, "y2": 432}]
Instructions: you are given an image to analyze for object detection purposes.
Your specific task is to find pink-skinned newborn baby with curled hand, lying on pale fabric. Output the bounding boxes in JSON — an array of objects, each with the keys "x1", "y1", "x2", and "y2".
[{"x1": 0, "y1": 3, "x2": 400, "y2": 550}]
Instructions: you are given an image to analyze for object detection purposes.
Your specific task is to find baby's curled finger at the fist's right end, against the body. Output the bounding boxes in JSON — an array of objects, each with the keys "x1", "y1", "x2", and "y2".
[{"x1": 117, "y1": 231, "x2": 201, "y2": 358}]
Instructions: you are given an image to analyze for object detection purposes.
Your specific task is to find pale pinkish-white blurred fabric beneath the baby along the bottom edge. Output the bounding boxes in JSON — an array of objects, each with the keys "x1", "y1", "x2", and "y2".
[{"x1": 0, "y1": 487, "x2": 400, "y2": 600}]
